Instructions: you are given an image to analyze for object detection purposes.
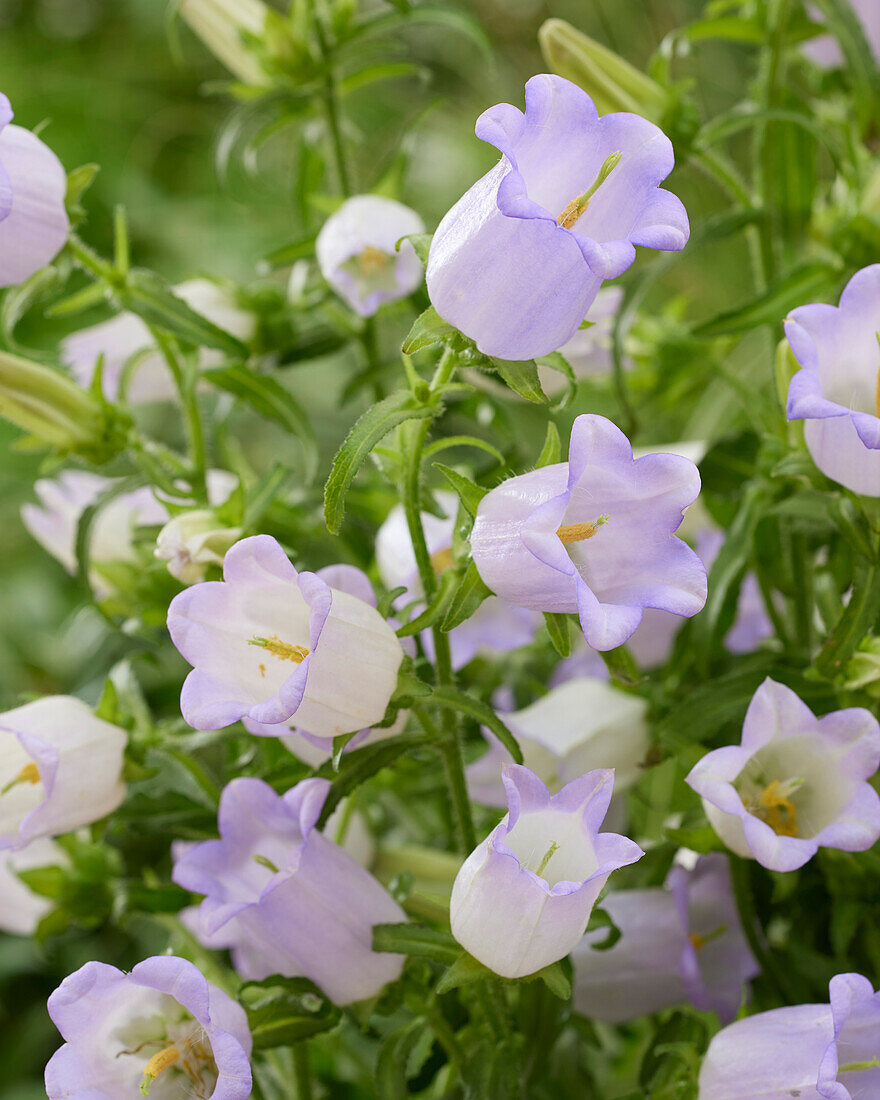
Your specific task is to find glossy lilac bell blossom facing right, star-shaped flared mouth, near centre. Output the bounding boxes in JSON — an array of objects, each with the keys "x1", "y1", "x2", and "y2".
[{"x1": 471, "y1": 415, "x2": 706, "y2": 650}]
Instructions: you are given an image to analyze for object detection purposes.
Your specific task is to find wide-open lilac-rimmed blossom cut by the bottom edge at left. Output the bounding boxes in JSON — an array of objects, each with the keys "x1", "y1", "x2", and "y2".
[{"x1": 45, "y1": 955, "x2": 252, "y2": 1100}]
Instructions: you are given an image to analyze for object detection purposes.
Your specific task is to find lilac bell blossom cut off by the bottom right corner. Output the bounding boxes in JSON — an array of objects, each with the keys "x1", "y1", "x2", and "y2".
[{"x1": 699, "y1": 974, "x2": 880, "y2": 1100}]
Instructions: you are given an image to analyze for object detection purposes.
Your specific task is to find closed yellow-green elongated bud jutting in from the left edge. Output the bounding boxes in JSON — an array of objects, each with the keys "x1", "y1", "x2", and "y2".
[{"x1": 0, "y1": 352, "x2": 124, "y2": 461}]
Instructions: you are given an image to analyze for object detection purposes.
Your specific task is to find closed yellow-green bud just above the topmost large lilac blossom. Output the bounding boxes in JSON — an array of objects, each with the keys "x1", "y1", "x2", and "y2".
[{"x1": 538, "y1": 19, "x2": 670, "y2": 122}]
